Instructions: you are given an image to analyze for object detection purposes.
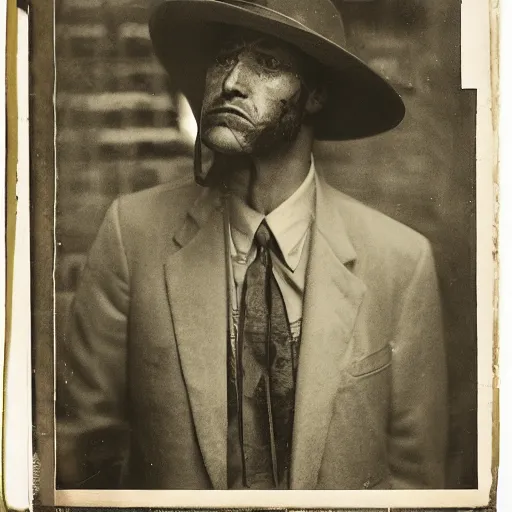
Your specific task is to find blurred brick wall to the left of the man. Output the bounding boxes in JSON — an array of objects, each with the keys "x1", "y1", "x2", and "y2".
[{"x1": 56, "y1": 0, "x2": 192, "y2": 329}]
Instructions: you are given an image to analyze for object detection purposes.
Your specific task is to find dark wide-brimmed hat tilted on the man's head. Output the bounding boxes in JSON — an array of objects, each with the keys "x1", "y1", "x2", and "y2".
[{"x1": 149, "y1": 0, "x2": 405, "y2": 140}]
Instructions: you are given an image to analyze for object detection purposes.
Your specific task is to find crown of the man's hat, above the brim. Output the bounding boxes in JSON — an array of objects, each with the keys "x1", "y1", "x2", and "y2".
[{"x1": 215, "y1": 0, "x2": 346, "y2": 46}]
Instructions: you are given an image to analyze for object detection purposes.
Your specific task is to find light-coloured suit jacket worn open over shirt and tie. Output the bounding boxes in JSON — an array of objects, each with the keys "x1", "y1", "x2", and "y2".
[{"x1": 57, "y1": 171, "x2": 447, "y2": 489}]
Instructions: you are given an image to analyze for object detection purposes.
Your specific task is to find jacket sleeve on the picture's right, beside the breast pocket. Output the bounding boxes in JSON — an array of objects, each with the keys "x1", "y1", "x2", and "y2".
[{"x1": 389, "y1": 240, "x2": 447, "y2": 489}]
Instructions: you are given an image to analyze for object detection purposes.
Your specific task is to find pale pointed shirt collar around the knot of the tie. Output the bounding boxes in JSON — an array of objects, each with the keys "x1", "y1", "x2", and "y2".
[{"x1": 230, "y1": 158, "x2": 315, "y2": 271}]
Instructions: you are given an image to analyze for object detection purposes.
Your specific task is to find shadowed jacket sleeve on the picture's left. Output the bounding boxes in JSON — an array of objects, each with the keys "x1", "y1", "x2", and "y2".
[{"x1": 56, "y1": 201, "x2": 129, "y2": 489}]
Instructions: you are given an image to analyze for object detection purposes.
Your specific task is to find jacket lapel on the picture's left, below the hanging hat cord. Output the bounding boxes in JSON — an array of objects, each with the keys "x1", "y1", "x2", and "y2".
[{"x1": 165, "y1": 188, "x2": 228, "y2": 489}]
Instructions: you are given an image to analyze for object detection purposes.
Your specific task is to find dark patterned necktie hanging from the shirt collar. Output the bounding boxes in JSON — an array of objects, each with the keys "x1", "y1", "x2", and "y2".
[{"x1": 240, "y1": 222, "x2": 295, "y2": 489}]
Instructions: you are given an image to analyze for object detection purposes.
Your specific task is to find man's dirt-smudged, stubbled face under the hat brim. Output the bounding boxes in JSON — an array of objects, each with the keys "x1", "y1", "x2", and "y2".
[{"x1": 201, "y1": 31, "x2": 314, "y2": 155}]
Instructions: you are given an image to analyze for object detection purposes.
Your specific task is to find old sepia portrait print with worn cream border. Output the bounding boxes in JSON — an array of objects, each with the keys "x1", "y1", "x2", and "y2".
[{"x1": 31, "y1": 0, "x2": 494, "y2": 508}]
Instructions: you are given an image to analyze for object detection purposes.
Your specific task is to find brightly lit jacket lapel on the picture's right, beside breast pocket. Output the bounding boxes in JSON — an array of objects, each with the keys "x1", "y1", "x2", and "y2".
[{"x1": 291, "y1": 179, "x2": 366, "y2": 489}]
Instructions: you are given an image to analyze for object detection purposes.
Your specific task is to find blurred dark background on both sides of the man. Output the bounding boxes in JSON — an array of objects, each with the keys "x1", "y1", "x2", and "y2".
[{"x1": 45, "y1": 0, "x2": 477, "y2": 488}]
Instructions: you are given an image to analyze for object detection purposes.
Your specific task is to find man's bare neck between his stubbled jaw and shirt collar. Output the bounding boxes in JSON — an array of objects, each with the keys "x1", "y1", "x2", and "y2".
[{"x1": 229, "y1": 128, "x2": 313, "y2": 215}]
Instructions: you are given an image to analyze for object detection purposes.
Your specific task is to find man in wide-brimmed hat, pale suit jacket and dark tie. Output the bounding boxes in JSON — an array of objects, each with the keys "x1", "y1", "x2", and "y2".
[{"x1": 57, "y1": 0, "x2": 446, "y2": 489}]
